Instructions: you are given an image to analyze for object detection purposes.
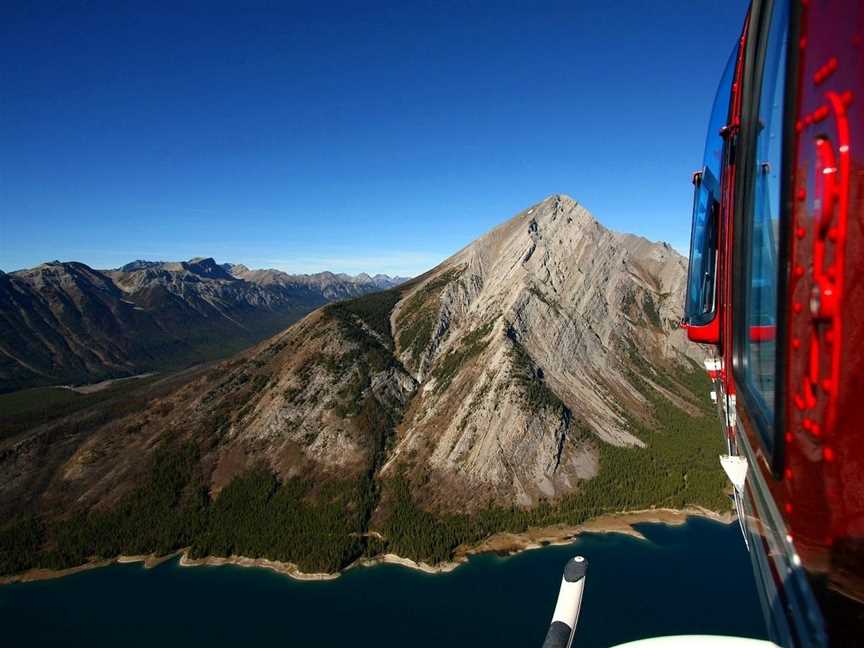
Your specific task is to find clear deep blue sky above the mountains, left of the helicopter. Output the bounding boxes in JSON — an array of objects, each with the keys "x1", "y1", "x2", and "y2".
[{"x1": 0, "y1": 0, "x2": 746, "y2": 275}]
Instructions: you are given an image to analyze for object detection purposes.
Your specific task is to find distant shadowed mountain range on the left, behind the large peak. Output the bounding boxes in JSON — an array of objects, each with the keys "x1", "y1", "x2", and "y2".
[{"x1": 0, "y1": 258, "x2": 405, "y2": 392}]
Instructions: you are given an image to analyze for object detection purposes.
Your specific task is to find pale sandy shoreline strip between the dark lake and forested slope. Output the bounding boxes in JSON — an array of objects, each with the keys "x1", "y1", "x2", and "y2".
[{"x1": 0, "y1": 507, "x2": 735, "y2": 585}]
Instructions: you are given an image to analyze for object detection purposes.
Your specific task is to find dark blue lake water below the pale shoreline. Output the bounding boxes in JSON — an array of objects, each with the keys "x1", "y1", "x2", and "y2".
[{"x1": 0, "y1": 519, "x2": 764, "y2": 648}]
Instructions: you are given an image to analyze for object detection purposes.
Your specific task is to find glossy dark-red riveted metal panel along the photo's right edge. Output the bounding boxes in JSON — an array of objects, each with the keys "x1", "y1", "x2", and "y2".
[{"x1": 780, "y1": 0, "x2": 864, "y2": 599}]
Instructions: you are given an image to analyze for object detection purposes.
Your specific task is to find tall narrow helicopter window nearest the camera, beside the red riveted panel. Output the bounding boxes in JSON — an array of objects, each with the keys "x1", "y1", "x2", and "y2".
[{"x1": 743, "y1": 2, "x2": 789, "y2": 434}]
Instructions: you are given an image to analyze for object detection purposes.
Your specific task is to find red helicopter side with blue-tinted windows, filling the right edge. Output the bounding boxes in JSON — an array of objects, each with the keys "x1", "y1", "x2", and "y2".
[{"x1": 684, "y1": 0, "x2": 864, "y2": 645}]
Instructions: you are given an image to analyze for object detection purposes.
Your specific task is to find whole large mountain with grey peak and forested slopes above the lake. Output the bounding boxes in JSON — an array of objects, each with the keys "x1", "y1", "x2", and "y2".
[{"x1": 0, "y1": 196, "x2": 728, "y2": 570}]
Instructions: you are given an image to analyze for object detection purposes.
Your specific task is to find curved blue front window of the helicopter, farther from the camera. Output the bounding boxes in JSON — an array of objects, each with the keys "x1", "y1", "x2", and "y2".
[{"x1": 684, "y1": 47, "x2": 738, "y2": 326}]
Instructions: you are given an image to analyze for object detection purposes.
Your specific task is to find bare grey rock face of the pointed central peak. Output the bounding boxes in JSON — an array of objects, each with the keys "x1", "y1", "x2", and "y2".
[{"x1": 389, "y1": 196, "x2": 701, "y2": 505}]
